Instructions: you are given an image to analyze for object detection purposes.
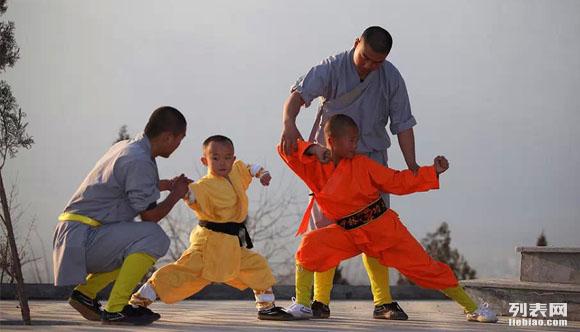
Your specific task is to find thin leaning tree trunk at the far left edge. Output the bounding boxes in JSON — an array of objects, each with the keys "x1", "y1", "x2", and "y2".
[{"x1": 0, "y1": 170, "x2": 30, "y2": 325}]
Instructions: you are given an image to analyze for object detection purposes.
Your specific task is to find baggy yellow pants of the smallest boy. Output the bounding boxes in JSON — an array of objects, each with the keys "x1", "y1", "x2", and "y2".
[{"x1": 149, "y1": 226, "x2": 276, "y2": 303}]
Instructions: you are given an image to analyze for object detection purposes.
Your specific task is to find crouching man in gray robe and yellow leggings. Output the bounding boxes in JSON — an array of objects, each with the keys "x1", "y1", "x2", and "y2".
[{"x1": 53, "y1": 106, "x2": 191, "y2": 325}]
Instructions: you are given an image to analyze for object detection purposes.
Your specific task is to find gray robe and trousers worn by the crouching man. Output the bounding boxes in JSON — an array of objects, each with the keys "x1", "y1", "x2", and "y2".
[{"x1": 53, "y1": 134, "x2": 169, "y2": 286}]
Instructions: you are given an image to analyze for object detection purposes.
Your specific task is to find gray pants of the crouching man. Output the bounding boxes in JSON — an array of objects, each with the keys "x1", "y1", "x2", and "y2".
[{"x1": 53, "y1": 221, "x2": 170, "y2": 286}]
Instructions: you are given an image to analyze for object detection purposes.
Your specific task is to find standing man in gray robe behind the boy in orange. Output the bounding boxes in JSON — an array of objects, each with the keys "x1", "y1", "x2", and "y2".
[{"x1": 280, "y1": 27, "x2": 419, "y2": 320}]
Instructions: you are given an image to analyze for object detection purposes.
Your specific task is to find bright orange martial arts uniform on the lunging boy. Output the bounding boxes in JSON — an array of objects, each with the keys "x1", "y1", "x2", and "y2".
[{"x1": 278, "y1": 141, "x2": 460, "y2": 290}]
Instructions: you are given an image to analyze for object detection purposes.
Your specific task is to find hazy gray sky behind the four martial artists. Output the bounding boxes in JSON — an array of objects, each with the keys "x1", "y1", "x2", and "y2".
[{"x1": 1, "y1": 0, "x2": 580, "y2": 284}]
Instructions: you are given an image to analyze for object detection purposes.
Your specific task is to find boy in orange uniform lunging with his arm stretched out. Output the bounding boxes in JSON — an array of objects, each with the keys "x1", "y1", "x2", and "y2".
[{"x1": 278, "y1": 114, "x2": 497, "y2": 322}]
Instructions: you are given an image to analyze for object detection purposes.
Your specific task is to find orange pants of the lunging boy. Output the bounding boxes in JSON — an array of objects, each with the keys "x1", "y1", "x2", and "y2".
[{"x1": 296, "y1": 209, "x2": 458, "y2": 289}]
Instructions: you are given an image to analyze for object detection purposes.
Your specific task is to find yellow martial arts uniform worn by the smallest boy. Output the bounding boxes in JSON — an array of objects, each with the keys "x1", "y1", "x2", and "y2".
[{"x1": 149, "y1": 160, "x2": 276, "y2": 303}]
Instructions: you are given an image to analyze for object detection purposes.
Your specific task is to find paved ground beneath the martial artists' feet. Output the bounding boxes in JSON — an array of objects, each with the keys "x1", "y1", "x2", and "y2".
[{"x1": 0, "y1": 300, "x2": 580, "y2": 332}]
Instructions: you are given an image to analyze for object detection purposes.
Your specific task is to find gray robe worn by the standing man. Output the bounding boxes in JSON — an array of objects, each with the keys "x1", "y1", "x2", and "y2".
[{"x1": 291, "y1": 49, "x2": 417, "y2": 228}]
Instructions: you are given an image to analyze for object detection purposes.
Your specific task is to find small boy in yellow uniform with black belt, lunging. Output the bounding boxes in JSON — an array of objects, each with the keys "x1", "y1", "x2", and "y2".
[{"x1": 130, "y1": 135, "x2": 293, "y2": 320}]
